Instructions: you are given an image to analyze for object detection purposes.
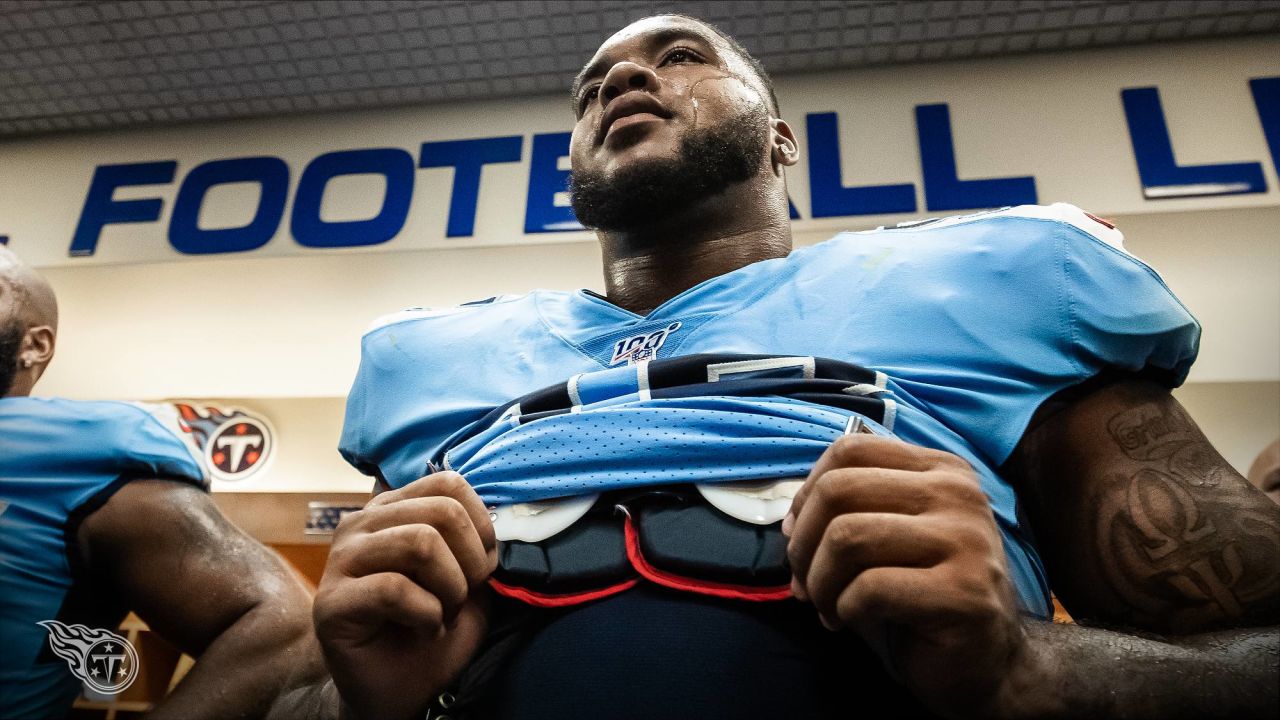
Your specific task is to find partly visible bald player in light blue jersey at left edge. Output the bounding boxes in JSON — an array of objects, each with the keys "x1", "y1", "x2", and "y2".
[{"x1": 0, "y1": 246, "x2": 319, "y2": 719}]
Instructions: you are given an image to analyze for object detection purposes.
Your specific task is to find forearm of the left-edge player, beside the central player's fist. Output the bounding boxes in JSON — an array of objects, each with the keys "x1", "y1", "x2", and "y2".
[{"x1": 150, "y1": 605, "x2": 327, "y2": 720}]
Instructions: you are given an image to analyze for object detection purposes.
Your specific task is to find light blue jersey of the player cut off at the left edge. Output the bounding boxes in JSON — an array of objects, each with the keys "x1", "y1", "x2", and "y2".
[{"x1": 0, "y1": 397, "x2": 207, "y2": 717}]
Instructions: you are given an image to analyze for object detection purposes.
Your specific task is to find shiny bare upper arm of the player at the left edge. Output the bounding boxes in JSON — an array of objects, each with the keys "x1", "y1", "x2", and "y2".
[{"x1": 78, "y1": 480, "x2": 308, "y2": 655}]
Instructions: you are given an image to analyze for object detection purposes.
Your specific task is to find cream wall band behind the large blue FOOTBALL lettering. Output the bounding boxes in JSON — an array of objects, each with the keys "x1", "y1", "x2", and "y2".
[{"x1": 0, "y1": 36, "x2": 1280, "y2": 268}]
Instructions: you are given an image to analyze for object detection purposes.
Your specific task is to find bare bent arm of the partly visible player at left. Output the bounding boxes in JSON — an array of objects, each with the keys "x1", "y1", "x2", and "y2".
[{"x1": 78, "y1": 480, "x2": 323, "y2": 719}]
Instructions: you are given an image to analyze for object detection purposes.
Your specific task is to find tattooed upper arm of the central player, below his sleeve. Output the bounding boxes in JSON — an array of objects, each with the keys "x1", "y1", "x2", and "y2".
[{"x1": 1006, "y1": 379, "x2": 1280, "y2": 633}]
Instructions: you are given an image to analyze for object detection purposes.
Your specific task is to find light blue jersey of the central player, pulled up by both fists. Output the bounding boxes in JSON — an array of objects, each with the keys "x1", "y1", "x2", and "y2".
[{"x1": 340, "y1": 205, "x2": 1199, "y2": 615}]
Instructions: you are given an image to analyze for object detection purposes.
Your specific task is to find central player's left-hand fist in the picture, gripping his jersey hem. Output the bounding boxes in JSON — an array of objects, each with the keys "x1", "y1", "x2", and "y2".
[{"x1": 315, "y1": 473, "x2": 498, "y2": 720}]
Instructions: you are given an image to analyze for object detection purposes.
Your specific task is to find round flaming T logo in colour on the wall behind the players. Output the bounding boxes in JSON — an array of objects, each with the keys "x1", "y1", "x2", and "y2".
[{"x1": 174, "y1": 402, "x2": 275, "y2": 482}]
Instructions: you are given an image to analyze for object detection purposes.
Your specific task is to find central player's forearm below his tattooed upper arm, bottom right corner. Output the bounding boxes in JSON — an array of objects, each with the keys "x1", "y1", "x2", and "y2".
[{"x1": 1001, "y1": 620, "x2": 1280, "y2": 719}]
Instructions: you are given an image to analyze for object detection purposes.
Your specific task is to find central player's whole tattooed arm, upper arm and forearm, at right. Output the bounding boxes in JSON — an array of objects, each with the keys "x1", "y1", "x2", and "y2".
[{"x1": 1006, "y1": 380, "x2": 1280, "y2": 717}]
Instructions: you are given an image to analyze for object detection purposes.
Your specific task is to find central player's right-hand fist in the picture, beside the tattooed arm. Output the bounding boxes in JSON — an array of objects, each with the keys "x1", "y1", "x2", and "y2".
[{"x1": 783, "y1": 434, "x2": 1027, "y2": 715}]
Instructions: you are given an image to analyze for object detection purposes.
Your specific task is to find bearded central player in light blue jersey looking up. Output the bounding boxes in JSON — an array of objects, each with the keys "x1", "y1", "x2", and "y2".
[{"x1": 316, "y1": 15, "x2": 1280, "y2": 717}]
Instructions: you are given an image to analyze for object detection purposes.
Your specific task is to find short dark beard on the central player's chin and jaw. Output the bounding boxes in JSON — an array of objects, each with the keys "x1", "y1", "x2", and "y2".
[{"x1": 570, "y1": 106, "x2": 769, "y2": 231}]
